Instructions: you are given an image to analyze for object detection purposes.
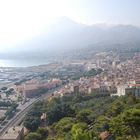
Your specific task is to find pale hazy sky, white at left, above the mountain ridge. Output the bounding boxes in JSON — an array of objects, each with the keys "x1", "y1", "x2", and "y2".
[{"x1": 0, "y1": 0, "x2": 140, "y2": 52}]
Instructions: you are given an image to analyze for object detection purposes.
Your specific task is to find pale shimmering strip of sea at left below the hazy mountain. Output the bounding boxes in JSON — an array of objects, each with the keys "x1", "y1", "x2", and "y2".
[{"x1": 0, "y1": 59, "x2": 50, "y2": 67}]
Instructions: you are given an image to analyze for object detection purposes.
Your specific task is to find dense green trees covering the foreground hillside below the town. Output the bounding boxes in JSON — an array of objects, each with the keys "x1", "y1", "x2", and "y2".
[{"x1": 24, "y1": 94, "x2": 140, "y2": 140}]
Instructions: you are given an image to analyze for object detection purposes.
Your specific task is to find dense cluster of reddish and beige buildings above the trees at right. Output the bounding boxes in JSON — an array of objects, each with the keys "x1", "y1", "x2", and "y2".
[{"x1": 54, "y1": 53, "x2": 140, "y2": 96}]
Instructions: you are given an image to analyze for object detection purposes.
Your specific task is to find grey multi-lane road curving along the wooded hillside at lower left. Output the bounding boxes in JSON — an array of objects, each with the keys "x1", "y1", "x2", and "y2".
[{"x1": 0, "y1": 87, "x2": 62, "y2": 136}]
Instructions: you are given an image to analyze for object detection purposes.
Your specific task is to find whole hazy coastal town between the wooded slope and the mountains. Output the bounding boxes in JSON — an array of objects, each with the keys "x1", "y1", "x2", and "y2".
[{"x1": 0, "y1": 51, "x2": 140, "y2": 140}]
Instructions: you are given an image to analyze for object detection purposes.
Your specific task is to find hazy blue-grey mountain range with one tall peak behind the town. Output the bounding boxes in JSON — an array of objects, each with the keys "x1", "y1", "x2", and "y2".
[{"x1": 1, "y1": 17, "x2": 140, "y2": 58}]
